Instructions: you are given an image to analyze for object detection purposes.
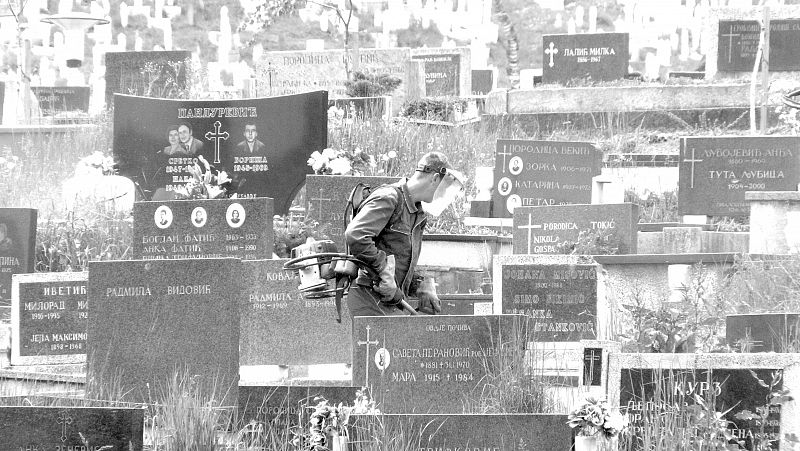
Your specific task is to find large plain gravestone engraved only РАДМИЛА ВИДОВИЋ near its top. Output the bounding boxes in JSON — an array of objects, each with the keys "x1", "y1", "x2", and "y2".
[{"x1": 87, "y1": 259, "x2": 243, "y2": 405}]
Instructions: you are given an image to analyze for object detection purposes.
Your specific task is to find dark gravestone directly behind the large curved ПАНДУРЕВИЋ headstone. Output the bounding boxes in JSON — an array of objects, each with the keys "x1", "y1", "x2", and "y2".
[{"x1": 105, "y1": 50, "x2": 192, "y2": 107}]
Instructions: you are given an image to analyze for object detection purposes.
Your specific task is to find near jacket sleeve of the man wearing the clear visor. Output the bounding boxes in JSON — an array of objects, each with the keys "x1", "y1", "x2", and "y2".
[{"x1": 344, "y1": 189, "x2": 398, "y2": 272}]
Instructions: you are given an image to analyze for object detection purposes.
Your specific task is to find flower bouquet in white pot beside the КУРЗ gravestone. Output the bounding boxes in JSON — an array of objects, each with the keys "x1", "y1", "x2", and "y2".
[{"x1": 567, "y1": 397, "x2": 628, "y2": 451}]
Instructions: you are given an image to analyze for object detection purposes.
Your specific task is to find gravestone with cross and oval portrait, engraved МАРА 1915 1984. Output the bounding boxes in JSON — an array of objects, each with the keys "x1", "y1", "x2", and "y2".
[{"x1": 352, "y1": 315, "x2": 527, "y2": 413}]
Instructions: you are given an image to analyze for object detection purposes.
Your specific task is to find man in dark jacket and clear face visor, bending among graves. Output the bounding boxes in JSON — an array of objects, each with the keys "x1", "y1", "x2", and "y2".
[{"x1": 345, "y1": 152, "x2": 464, "y2": 316}]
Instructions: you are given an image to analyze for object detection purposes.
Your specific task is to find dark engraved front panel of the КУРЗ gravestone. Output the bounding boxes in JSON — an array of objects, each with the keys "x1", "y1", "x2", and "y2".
[{"x1": 620, "y1": 368, "x2": 783, "y2": 450}]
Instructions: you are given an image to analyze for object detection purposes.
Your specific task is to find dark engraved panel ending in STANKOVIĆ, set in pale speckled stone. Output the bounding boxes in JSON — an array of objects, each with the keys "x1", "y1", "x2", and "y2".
[{"x1": 501, "y1": 264, "x2": 597, "y2": 342}]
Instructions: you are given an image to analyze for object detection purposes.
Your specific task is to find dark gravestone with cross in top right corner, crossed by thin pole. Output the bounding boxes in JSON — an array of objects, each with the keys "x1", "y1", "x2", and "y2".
[{"x1": 717, "y1": 19, "x2": 800, "y2": 72}]
